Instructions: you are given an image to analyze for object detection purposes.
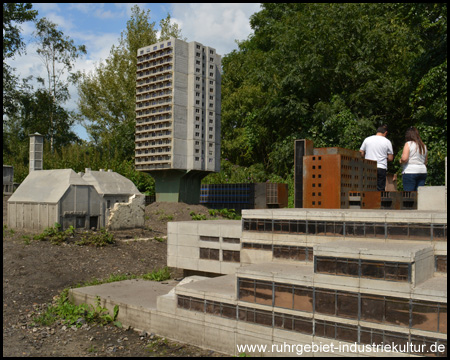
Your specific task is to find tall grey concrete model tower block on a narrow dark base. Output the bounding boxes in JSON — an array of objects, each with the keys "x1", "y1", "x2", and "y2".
[{"x1": 135, "y1": 38, "x2": 221, "y2": 203}]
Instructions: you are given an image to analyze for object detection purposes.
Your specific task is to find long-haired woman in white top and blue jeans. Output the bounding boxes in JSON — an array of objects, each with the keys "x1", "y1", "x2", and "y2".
[{"x1": 400, "y1": 126, "x2": 428, "y2": 191}]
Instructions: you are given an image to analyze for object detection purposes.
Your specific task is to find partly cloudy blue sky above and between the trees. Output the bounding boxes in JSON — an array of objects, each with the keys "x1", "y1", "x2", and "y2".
[{"x1": 8, "y1": 3, "x2": 260, "y2": 140}]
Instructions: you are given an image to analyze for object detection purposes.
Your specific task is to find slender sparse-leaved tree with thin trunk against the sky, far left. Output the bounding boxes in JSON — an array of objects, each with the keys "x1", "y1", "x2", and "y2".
[{"x1": 35, "y1": 18, "x2": 86, "y2": 152}]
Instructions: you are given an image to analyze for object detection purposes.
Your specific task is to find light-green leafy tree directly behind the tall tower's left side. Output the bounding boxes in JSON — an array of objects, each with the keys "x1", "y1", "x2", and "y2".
[{"x1": 78, "y1": 5, "x2": 185, "y2": 159}]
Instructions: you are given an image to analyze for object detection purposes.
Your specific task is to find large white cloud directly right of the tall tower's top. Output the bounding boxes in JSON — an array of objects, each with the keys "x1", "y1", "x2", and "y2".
[{"x1": 171, "y1": 3, "x2": 260, "y2": 56}]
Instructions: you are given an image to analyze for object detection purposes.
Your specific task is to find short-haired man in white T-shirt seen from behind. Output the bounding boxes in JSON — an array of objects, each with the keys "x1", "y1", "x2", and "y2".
[{"x1": 359, "y1": 125, "x2": 394, "y2": 191}]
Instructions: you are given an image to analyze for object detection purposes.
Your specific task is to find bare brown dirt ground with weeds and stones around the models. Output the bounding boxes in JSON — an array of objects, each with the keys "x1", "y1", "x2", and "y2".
[{"x1": 3, "y1": 196, "x2": 229, "y2": 357}]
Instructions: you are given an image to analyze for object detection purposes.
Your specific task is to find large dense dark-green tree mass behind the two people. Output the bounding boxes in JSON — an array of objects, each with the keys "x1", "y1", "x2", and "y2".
[{"x1": 222, "y1": 3, "x2": 447, "y2": 180}]
